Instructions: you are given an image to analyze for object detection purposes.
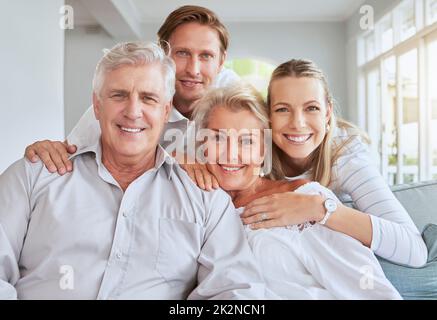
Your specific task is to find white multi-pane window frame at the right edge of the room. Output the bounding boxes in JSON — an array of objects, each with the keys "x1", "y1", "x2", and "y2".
[{"x1": 357, "y1": 0, "x2": 437, "y2": 184}]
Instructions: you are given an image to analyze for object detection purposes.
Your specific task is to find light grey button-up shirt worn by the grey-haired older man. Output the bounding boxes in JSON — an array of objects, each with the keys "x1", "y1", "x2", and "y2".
[{"x1": 0, "y1": 142, "x2": 265, "y2": 299}]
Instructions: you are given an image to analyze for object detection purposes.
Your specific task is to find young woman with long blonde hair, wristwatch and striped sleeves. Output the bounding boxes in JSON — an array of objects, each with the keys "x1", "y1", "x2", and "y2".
[{"x1": 243, "y1": 60, "x2": 427, "y2": 267}]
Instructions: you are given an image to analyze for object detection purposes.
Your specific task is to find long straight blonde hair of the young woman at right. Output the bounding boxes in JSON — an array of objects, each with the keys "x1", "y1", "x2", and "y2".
[{"x1": 267, "y1": 59, "x2": 370, "y2": 186}]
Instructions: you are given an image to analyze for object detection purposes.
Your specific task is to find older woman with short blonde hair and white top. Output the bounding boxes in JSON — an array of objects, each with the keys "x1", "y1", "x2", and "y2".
[{"x1": 189, "y1": 85, "x2": 400, "y2": 299}]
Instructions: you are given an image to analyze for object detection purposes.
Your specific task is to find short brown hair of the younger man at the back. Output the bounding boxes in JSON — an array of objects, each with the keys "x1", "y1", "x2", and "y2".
[{"x1": 158, "y1": 5, "x2": 229, "y2": 55}]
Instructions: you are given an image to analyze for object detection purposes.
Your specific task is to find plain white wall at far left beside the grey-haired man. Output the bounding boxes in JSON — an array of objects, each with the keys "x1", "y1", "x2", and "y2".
[{"x1": 0, "y1": 0, "x2": 64, "y2": 173}]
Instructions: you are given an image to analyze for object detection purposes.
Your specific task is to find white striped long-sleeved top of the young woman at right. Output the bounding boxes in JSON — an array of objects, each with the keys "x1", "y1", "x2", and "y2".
[{"x1": 287, "y1": 128, "x2": 428, "y2": 267}]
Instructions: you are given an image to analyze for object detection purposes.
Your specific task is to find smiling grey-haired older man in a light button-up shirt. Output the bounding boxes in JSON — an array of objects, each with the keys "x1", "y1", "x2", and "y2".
[{"x1": 0, "y1": 43, "x2": 265, "y2": 299}]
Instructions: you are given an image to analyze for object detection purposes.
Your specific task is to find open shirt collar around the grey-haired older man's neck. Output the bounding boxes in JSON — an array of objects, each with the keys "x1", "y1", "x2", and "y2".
[{"x1": 69, "y1": 138, "x2": 176, "y2": 179}]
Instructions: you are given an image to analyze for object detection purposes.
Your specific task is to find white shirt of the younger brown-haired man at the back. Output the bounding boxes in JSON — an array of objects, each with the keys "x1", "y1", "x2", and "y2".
[{"x1": 67, "y1": 68, "x2": 240, "y2": 154}]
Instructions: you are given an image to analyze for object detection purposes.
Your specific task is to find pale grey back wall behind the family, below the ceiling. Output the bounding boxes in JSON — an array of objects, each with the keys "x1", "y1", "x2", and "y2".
[{"x1": 65, "y1": 23, "x2": 347, "y2": 134}]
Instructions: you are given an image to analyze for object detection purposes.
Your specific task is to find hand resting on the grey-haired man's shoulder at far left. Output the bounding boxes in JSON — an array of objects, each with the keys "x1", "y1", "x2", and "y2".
[{"x1": 24, "y1": 140, "x2": 77, "y2": 176}]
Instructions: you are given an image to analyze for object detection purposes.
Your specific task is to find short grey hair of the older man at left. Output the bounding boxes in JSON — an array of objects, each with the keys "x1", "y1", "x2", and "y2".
[{"x1": 93, "y1": 42, "x2": 176, "y2": 100}]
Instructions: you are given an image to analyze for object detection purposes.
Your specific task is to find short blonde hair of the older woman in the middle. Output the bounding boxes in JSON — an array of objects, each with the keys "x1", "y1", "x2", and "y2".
[{"x1": 192, "y1": 83, "x2": 270, "y2": 129}]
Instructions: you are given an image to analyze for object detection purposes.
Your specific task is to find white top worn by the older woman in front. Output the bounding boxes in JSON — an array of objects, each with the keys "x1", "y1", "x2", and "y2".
[{"x1": 237, "y1": 182, "x2": 402, "y2": 299}]
